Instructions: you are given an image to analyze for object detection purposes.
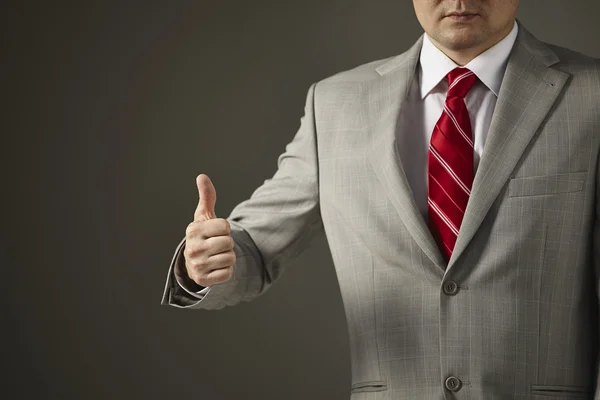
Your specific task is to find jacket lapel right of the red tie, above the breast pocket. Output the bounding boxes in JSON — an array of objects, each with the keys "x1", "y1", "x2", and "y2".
[{"x1": 447, "y1": 24, "x2": 569, "y2": 270}]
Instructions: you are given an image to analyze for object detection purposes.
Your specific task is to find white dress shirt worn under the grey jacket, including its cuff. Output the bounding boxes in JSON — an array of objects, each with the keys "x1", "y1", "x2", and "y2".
[{"x1": 176, "y1": 21, "x2": 519, "y2": 299}]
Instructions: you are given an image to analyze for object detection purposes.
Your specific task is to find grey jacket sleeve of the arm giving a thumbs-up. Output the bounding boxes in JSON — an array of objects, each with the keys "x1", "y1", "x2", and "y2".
[{"x1": 162, "y1": 84, "x2": 323, "y2": 310}]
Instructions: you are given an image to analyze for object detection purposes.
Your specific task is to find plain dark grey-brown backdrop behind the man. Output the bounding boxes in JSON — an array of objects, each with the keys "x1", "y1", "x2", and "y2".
[{"x1": 0, "y1": 0, "x2": 600, "y2": 400}]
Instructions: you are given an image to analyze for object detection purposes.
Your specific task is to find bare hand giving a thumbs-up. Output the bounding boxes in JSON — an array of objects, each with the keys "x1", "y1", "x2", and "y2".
[{"x1": 183, "y1": 174, "x2": 236, "y2": 286}]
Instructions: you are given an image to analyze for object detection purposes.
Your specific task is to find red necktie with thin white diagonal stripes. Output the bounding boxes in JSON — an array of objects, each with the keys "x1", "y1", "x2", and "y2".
[{"x1": 427, "y1": 68, "x2": 477, "y2": 262}]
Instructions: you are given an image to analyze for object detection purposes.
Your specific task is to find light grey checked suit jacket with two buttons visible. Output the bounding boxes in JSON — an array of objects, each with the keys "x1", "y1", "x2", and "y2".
[{"x1": 162, "y1": 25, "x2": 600, "y2": 400}]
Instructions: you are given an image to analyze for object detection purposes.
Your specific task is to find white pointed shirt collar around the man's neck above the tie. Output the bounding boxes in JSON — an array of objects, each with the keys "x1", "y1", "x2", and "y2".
[{"x1": 419, "y1": 21, "x2": 519, "y2": 99}]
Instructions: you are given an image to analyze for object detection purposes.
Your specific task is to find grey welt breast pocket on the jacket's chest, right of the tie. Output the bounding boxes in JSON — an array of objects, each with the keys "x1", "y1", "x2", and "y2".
[{"x1": 508, "y1": 171, "x2": 588, "y2": 197}]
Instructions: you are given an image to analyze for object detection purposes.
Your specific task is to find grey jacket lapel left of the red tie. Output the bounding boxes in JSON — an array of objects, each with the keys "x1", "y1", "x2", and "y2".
[{"x1": 361, "y1": 37, "x2": 444, "y2": 276}]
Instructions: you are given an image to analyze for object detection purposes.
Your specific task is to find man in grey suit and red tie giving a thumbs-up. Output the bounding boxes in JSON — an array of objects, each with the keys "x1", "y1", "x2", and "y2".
[{"x1": 163, "y1": 0, "x2": 600, "y2": 400}]
